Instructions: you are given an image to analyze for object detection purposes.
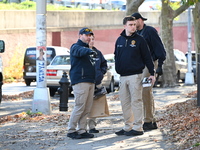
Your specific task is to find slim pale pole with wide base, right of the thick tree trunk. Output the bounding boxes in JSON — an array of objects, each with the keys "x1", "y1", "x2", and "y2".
[{"x1": 185, "y1": 7, "x2": 194, "y2": 85}]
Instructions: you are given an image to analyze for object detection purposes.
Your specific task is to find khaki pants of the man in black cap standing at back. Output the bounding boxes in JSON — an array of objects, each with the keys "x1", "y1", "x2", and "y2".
[{"x1": 142, "y1": 61, "x2": 158, "y2": 122}]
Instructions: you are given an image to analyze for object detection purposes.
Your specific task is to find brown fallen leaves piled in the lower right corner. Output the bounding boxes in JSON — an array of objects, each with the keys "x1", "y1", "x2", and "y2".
[{"x1": 158, "y1": 99, "x2": 200, "y2": 149}]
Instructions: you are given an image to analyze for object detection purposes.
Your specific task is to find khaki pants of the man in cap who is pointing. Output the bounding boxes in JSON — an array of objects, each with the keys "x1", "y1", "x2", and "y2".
[{"x1": 68, "y1": 83, "x2": 95, "y2": 134}]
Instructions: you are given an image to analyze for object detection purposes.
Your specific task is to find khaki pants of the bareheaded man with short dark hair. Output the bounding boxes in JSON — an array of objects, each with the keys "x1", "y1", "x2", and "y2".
[{"x1": 119, "y1": 74, "x2": 144, "y2": 131}]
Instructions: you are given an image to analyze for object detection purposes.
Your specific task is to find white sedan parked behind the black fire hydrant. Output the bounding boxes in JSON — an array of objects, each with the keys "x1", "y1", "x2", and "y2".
[{"x1": 47, "y1": 55, "x2": 114, "y2": 96}]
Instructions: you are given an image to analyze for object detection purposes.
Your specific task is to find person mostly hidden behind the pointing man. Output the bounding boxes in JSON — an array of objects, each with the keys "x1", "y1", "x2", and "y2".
[{"x1": 88, "y1": 35, "x2": 108, "y2": 133}]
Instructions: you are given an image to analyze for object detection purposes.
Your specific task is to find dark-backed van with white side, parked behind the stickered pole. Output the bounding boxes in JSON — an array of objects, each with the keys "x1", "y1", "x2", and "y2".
[{"x1": 23, "y1": 46, "x2": 69, "y2": 86}]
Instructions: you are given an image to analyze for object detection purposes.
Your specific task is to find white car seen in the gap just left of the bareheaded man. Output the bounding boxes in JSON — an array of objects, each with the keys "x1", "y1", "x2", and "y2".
[{"x1": 104, "y1": 54, "x2": 120, "y2": 86}]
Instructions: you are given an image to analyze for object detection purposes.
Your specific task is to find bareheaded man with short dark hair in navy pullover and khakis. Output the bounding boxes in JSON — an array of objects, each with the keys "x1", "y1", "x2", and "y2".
[{"x1": 114, "y1": 16, "x2": 155, "y2": 136}]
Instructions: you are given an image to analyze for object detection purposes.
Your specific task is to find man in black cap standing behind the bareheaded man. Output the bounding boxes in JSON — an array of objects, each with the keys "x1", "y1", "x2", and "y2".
[{"x1": 132, "y1": 12, "x2": 166, "y2": 131}]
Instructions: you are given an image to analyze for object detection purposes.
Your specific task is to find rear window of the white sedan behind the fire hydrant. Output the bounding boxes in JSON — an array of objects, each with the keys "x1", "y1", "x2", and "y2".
[{"x1": 51, "y1": 55, "x2": 70, "y2": 65}]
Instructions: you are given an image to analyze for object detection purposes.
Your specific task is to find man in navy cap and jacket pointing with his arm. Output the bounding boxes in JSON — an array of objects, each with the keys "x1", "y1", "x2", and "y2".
[{"x1": 67, "y1": 28, "x2": 96, "y2": 139}]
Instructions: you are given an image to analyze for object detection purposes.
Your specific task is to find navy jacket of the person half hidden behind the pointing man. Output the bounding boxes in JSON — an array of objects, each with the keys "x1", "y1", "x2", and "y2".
[{"x1": 92, "y1": 47, "x2": 108, "y2": 85}]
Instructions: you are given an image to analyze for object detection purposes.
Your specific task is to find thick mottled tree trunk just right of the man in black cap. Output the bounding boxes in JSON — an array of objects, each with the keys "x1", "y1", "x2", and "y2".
[{"x1": 160, "y1": 0, "x2": 176, "y2": 87}]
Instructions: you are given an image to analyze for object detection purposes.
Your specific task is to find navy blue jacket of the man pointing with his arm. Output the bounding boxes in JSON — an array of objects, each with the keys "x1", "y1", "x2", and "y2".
[{"x1": 69, "y1": 39, "x2": 95, "y2": 85}]
